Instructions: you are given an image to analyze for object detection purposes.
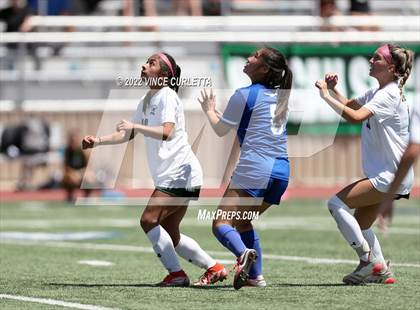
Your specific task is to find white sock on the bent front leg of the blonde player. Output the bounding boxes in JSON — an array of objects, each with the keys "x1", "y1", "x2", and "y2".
[{"x1": 328, "y1": 196, "x2": 370, "y2": 261}]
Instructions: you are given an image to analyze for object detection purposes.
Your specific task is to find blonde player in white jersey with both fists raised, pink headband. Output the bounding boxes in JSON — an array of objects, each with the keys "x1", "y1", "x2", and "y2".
[{"x1": 315, "y1": 44, "x2": 414, "y2": 284}]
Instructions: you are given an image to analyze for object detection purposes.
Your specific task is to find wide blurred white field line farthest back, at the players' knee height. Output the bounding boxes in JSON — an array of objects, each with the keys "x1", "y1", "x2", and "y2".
[{"x1": 0, "y1": 217, "x2": 420, "y2": 235}]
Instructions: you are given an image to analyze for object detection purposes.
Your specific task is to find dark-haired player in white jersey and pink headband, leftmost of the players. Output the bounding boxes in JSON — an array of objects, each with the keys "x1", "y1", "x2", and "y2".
[{"x1": 83, "y1": 53, "x2": 227, "y2": 286}]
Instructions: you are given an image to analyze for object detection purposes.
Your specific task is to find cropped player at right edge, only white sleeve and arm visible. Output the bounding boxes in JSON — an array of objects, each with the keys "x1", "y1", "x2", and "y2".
[{"x1": 379, "y1": 102, "x2": 420, "y2": 225}]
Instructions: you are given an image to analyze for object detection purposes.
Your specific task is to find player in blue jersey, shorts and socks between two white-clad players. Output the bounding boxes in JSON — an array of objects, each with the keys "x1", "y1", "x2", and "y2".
[{"x1": 199, "y1": 47, "x2": 293, "y2": 289}]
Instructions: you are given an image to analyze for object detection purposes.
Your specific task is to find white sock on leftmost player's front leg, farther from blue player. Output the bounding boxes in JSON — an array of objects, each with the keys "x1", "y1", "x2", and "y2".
[{"x1": 147, "y1": 225, "x2": 181, "y2": 272}]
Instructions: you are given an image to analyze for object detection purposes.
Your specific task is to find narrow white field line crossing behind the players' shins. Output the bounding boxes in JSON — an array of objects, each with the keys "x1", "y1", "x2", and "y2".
[{"x1": 0, "y1": 239, "x2": 420, "y2": 268}]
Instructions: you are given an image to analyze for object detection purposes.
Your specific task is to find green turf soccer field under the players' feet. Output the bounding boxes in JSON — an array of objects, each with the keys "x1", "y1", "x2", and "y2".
[{"x1": 0, "y1": 200, "x2": 420, "y2": 309}]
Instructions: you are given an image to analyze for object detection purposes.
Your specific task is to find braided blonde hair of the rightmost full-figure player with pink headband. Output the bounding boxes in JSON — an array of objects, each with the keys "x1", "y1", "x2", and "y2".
[{"x1": 388, "y1": 44, "x2": 414, "y2": 101}]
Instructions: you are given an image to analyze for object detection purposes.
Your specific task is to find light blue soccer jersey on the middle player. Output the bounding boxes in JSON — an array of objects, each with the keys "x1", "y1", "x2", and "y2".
[{"x1": 221, "y1": 83, "x2": 290, "y2": 193}]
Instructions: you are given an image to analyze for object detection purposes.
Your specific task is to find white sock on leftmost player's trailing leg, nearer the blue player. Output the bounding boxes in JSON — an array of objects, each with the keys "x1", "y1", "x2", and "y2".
[{"x1": 175, "y1": 234, "x2": 216, "y2": 270}]
